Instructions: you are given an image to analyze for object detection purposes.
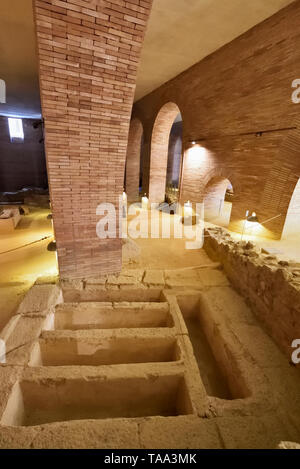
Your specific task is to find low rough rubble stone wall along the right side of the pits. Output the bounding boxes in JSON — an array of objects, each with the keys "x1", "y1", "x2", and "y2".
[{"x1": 204, "y1": 228, "x2": 300, "y2": 358}]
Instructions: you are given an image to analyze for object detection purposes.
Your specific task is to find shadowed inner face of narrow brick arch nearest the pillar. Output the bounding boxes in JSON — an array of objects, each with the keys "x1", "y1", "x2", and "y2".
[{"x1": 125, "y1": 117, "x2": 144, "y2": 200}]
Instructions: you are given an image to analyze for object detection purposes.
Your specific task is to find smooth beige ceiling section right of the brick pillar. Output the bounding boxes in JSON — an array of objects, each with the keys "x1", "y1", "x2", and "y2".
[{"x1": 135, "y1": 0, "x2": 293, "y2": 100}]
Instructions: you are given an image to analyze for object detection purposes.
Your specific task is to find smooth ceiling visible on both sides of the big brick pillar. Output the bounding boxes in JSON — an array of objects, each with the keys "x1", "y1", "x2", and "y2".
[{"x1": 0, "y1": 0, "x2": 293, "y2": 117}]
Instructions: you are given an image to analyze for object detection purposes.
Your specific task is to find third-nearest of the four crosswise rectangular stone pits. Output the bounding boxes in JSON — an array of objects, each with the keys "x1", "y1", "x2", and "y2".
[{"x1": 53, "y1": 302, "x2": 174, "y2": 330}]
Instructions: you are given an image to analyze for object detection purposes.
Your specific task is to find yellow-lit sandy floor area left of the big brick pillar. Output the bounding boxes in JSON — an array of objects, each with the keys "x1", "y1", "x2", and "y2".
[{"x1": 0, "y1": 208, "x2": 57, "y2": 330}]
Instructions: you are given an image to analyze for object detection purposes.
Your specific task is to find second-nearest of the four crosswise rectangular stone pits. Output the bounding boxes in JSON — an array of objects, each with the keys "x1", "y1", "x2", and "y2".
[{"x1": 29, "y1": 337, "x2": 180, "y2": 366}]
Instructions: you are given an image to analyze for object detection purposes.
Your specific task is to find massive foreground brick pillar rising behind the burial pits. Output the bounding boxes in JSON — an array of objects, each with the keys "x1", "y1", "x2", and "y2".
[{"x1": 33, "y1": 0, "x2": 152, "y2": 278}]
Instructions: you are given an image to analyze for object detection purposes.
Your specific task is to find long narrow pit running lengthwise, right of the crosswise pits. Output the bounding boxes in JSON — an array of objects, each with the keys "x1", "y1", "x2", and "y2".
[{"x1": 177, "y1": 294, "x2": 249, "y2": 400}]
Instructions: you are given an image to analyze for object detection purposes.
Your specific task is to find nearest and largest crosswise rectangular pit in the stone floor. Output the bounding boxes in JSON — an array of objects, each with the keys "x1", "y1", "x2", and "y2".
[{"x1": 1, "y1": 375, "x2": 193, "y2": 426}]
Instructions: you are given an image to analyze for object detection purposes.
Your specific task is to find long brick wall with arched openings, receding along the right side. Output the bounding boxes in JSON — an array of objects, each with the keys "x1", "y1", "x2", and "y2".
[{"x1": 133, "y1": 0, "x2": 300, "y2": 238}]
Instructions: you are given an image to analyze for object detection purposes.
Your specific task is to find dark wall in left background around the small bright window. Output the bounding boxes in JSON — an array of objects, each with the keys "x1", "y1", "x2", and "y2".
[{"x1": 0, "y1": 117, "x2": 48, "y2": 192}]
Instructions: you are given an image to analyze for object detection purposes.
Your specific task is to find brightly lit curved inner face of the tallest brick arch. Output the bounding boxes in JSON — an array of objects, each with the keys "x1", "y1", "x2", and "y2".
[{"x1": 149, "y1": 102, "x2": 180, "y2": 203}]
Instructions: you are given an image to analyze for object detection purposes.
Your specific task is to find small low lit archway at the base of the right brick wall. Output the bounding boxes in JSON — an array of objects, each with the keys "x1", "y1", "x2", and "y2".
[{"x1": 203, "y1": 176, "x2": 234, "y2": 228}]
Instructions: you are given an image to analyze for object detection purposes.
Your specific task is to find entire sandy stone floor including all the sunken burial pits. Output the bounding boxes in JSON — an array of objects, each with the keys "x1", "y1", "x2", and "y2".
[{"x1": 0, "y1": 204, "x2": 300, "y2": 448}]
